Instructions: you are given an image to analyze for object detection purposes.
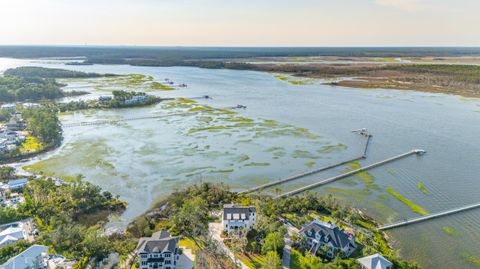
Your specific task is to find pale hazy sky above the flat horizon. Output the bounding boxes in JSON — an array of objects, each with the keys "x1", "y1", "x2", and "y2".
[{"x1": 0, "y1": 0, "x2": 480, "y2": 46}]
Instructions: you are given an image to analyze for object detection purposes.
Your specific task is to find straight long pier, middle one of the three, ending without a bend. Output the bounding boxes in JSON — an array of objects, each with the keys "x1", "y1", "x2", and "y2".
[{"x1": 275, "y1": 149, "x2": 425, "y2": 198}]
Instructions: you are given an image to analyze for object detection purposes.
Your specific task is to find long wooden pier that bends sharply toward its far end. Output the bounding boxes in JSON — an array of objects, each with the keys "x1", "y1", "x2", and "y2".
[{"x1": 239, "y1": 132, "x2": 372, "y2": 193}]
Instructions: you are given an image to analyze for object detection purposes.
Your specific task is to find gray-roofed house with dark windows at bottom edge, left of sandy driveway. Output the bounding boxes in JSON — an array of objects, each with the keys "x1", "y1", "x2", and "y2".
[{"x1": 136, "y1": 230, "x2": 180, "y2": 269}]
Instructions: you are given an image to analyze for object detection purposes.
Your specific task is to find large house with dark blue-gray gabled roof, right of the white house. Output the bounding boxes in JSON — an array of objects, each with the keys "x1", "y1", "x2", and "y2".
[{"x1": 299, "y1": 220, "x2": 356, "y2": 258}]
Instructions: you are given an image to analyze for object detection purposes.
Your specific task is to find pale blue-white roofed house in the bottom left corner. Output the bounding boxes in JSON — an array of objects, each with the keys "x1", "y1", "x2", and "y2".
[{"x1": 0, "y1": 245, "x2": 48, "y2": 269}]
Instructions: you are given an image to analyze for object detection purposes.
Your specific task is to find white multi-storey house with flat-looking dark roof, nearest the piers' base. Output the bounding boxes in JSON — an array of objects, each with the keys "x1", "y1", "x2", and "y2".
[{"x1": 222, "y1": 205, "x2": 257, "y2": 232}]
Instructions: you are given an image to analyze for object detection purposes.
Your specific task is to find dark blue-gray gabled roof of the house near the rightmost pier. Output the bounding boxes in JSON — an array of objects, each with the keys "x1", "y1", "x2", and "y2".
[{"x1": 300, "y1": 220, "x2": 351, "y2": 248}]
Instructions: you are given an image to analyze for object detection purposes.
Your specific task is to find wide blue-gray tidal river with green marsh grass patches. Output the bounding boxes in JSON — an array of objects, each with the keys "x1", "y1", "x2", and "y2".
[{"x1": 0, "y1": 57, "x2": 480, "y2": 268}]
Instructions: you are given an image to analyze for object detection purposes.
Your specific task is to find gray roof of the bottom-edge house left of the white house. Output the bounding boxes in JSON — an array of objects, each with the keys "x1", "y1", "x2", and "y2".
[{"x1": 137, "y1": 230, "x2": 178, "y2": 253}]
